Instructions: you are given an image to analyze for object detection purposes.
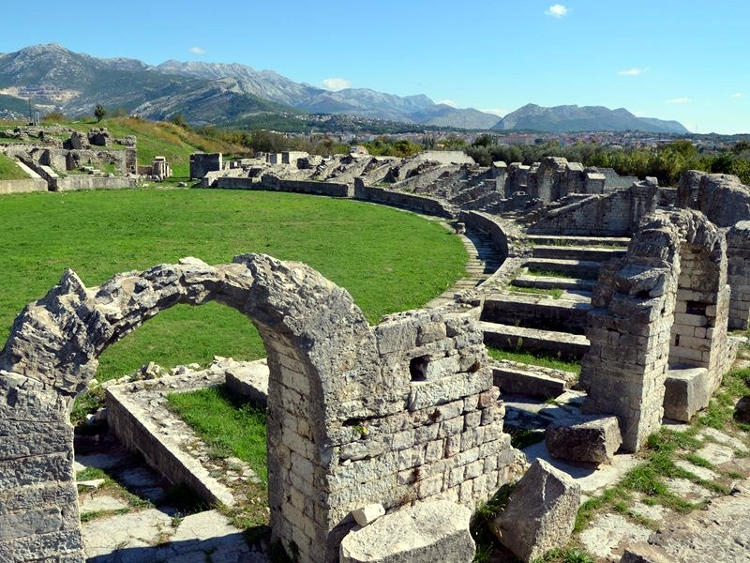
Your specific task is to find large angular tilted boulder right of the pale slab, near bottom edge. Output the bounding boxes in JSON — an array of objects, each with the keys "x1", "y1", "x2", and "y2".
[{"x1": 491, "y1": 459, "x2": 581, "y2": 561}]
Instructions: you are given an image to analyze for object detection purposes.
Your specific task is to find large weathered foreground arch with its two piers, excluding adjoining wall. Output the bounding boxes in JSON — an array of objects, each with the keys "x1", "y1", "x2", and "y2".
[{"x1": 0, "y1": 254, "x2": 378, "y2": 561}]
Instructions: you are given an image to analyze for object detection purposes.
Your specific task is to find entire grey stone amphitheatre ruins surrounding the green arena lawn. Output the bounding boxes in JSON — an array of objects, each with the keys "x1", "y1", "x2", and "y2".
[{"x1": 0, "y1": 125, "x2": 750, "y2": 562}]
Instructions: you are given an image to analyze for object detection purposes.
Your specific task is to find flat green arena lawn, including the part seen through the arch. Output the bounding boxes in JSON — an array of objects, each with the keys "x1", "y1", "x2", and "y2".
[{"x1": 0, "y1": 190, "x2": 466, "y2": 379}]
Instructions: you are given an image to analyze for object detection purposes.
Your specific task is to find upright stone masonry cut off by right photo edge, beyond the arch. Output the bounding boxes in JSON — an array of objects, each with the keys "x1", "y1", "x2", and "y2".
[{"x1": 727, "y1": 221, "x2": 750, "y2": 330}]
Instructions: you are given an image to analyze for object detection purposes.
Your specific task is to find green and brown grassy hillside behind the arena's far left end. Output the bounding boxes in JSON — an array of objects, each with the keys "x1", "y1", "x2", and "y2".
[{"x1": 63, "y1": 117, "x2": 242, "y2": 177}]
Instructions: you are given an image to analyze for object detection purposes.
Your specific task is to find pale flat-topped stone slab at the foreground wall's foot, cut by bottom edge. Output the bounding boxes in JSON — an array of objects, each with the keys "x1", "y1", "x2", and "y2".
[{"x1": 339, "y1": 500, "x2": 475, "y2": 563}]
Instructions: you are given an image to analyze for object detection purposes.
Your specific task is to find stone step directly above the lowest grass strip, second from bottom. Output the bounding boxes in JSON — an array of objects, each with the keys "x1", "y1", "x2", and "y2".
[{"x1": 480, "y1": 322, "x2": 589, "y2": 360}]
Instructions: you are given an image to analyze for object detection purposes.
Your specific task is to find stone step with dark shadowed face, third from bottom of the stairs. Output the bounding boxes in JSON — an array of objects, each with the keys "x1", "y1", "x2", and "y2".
[{"x1": 480, "y1": 294, "x2": 591, "y2": 334}]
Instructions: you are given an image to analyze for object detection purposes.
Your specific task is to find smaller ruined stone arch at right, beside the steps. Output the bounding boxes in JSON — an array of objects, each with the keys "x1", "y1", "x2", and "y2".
[{"x1": 581, "y1": 210, "x2": 729, "y2": 451}]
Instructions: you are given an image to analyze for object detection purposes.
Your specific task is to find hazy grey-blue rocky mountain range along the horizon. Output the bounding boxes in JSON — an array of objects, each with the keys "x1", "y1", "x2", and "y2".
[{"x1": 0, "y1": 43, "x2": 687, "y2": 133}]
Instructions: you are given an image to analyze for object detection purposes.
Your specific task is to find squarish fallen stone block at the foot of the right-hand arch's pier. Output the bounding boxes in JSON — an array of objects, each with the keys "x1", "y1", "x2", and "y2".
[{"x1": 544, "y1": 416, "x2": 622, "y2": 464}]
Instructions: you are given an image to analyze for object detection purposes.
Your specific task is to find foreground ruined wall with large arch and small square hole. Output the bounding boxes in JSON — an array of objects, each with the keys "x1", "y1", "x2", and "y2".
[{"x1": 0, "y1": 255, "x2": 523, "y2": 561}]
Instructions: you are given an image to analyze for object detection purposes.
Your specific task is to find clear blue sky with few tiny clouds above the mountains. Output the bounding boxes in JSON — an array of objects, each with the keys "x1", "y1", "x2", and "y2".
[{"x1": 0, "y1": 0, "x2": 750, "y2": 133}]
